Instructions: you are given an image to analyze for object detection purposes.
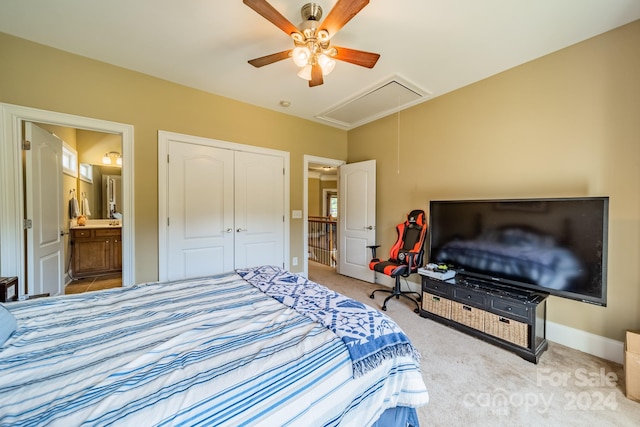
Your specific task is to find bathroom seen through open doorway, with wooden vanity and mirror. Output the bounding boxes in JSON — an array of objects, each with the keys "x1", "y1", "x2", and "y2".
[{"x1": 31, "y1": 122, "x2": 123, "y2": 294}]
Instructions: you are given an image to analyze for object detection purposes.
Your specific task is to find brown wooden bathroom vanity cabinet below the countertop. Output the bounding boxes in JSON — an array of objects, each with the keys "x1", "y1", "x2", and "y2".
[{"x1": 71, "y1": 227, "x2": 122, "y2": 278}]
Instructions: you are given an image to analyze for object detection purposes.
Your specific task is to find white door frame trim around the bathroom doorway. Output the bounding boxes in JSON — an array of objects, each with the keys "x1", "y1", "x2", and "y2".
[{"x1": 0, "y1": 104, "x2": 135, "y2": 298}]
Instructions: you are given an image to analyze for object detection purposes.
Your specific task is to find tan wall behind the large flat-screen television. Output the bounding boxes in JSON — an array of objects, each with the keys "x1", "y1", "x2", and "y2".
[{"x1": 348, "y1": 21, "x2": 640, "y2": 340}]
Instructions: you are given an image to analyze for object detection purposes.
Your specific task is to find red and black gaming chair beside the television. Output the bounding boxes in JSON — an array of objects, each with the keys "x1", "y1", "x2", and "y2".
[{"x1": 367, "y1": 210, "x2": 427, "y2": 313}]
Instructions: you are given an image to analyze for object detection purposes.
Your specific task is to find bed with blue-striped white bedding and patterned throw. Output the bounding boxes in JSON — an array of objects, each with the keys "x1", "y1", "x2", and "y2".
[{"x1": 0, "y1": 266, "x2": 428, "y2": 427}]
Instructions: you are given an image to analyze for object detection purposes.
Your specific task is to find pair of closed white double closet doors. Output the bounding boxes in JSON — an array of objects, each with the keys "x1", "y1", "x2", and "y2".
[{"x1": 163, "y1": 141, "x2": 285, "y2": 280}]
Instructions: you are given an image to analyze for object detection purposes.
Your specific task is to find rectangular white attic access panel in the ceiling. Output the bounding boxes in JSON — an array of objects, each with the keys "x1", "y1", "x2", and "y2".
[{"x1": 316, "y1": 76, "x2": 429, "y2": 129}]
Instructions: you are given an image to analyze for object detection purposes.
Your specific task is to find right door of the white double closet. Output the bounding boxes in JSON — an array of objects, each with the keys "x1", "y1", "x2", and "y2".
[{"x1": 235, "y1": 151, "x2": 285, "y2": 268}]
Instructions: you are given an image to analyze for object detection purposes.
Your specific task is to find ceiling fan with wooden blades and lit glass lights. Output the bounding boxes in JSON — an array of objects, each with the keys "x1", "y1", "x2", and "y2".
[{"x1": 243, "y1": 0, "x2": 380, "y2": 87}]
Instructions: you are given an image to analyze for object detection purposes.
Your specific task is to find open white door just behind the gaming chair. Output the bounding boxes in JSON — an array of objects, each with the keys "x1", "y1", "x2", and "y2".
[{"x1": 338, "y1": 160, "x2": 376, "y2": 283}]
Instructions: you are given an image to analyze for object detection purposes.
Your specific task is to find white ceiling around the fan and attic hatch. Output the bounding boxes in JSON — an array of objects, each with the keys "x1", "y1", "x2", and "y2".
[{"x1": 0, "y1": 0, "x2": 640, "y2": 129}]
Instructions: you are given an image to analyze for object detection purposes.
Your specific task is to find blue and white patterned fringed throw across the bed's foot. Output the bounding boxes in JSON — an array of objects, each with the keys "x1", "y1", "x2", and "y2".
[{"x1": 237, "y1": 266, "x2": 420, "y2": 378}]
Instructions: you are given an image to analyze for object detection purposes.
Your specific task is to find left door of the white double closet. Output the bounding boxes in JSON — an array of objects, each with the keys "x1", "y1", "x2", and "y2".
[{"x1": 161, "y1": 141, "x2": 234, "y2": 280}]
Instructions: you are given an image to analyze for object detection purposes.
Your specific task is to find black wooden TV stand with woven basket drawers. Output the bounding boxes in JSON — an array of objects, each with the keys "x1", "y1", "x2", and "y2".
[{"x1": 420, "y1": 275, "x2": 548, "y2": 363}]
